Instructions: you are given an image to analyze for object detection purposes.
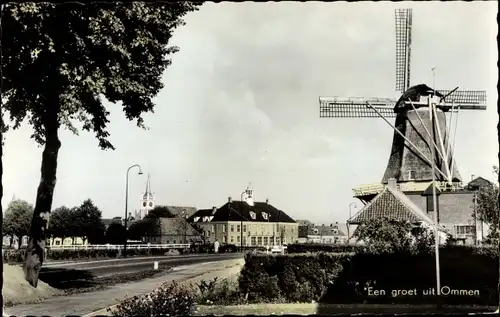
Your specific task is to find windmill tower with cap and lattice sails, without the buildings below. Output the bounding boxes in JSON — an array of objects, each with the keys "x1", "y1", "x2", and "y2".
[{"x1": 319, "y1": 9, "x2": 486, "y2": 201}]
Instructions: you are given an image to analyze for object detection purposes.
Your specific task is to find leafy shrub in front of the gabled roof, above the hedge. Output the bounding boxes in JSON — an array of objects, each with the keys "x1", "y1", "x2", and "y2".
[{"x1": 354, "y1": 218, "x2": 434, "y2": 252}]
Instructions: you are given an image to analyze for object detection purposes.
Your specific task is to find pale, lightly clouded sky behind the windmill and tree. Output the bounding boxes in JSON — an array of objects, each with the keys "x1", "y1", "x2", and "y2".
[{"x1": 2, "y1": 1, "x2": 499, "y2": 224}]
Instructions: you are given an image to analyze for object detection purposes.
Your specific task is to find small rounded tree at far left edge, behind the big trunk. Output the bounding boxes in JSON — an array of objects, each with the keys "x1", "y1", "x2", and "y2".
[{"x1": 2, "y1": 199, "x2": 33, "y2": 247}]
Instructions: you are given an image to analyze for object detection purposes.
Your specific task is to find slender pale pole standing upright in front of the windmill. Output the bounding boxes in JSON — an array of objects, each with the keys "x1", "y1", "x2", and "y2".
[{"x1": 429, "y1": 98, "x2": 441, "y2": 308}]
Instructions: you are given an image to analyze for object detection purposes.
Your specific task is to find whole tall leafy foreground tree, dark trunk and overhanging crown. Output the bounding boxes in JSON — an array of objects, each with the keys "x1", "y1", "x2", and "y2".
[{"x1": 1, "y1": 2, "x2": 201, "y2": 287}]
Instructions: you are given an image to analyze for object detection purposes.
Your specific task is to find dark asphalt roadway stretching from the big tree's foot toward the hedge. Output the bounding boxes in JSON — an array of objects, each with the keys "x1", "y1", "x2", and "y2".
[{"x1": 40, "y1": 253, "x2": 243, "y2": 286}]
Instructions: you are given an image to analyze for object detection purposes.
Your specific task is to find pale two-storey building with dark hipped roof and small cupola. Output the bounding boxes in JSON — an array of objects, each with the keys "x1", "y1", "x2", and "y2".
[{"x1": 188, "y1": 189, "x2": 298, "y2": 246}]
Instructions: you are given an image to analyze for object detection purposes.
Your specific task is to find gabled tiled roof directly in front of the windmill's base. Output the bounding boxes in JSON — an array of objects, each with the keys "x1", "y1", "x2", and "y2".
[{"x1": 349, "y1": 187, "x2": 445, "y2": 231}]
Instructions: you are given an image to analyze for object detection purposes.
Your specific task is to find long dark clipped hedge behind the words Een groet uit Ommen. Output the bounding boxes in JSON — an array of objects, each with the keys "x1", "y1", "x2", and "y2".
[{"x1": 239, "y1": 247, "x2": 498, "y2": 305}]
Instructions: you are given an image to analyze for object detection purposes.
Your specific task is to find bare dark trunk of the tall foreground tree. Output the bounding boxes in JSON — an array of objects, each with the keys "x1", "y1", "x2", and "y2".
[{"x1": 23, "y1": 110, "x2": 61, "y2": 287}]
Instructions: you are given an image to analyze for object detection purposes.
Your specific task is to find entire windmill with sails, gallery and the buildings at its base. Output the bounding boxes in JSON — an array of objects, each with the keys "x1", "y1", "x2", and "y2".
[{"x1": 319, "y1": 9, "x2": 487, "y2": 244}]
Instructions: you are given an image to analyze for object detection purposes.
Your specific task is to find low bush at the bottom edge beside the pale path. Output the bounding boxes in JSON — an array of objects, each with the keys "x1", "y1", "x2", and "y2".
[{"x1": 108, "y1": 282, "x2": 196, "y2": 317}]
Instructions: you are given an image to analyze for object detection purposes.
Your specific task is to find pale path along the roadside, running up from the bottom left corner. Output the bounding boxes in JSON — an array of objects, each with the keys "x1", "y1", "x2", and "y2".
[{"x1": 6, "y1": 258, "x2": 244, "y2": 317}]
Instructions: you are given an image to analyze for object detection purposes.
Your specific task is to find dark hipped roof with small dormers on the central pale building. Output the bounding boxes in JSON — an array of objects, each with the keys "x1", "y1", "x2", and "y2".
[{"x1": 188, "y1": 201, "x2": 295, "y2": 223}]
